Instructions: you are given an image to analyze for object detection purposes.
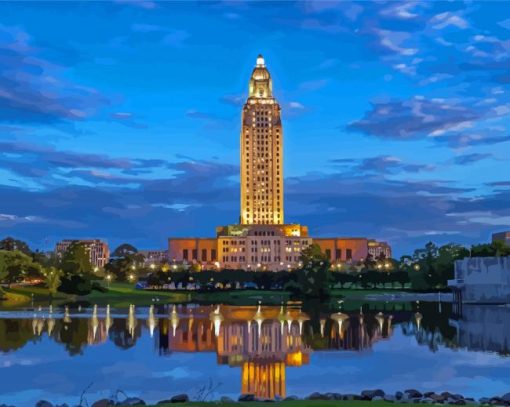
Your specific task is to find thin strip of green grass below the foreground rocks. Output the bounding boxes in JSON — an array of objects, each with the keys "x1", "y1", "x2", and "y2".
[{"x1": 153, "y1": 400, "x2": 389, "y2": 407}]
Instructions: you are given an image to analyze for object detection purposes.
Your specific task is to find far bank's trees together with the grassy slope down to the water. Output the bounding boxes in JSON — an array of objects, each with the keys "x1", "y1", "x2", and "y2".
[{"x1": 0, "y1": 238, "x2": 510, "y2": 306}]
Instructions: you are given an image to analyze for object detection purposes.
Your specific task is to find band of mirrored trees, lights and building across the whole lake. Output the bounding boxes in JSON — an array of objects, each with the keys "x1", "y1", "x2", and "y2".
[{"x1": 0, "y1": 304, "x2": 510, "y2": 399}]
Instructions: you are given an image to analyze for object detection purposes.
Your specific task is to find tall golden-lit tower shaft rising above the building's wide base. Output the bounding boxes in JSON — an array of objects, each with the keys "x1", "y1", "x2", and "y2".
[{"x1": 241, "y1": 55, "x2": 283, "y2": 224}]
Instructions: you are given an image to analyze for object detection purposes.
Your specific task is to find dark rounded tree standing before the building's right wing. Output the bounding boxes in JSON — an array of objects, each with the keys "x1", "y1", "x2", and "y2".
[{"x1": 296, "y1": 244, "x2": 332, "y2": 299}]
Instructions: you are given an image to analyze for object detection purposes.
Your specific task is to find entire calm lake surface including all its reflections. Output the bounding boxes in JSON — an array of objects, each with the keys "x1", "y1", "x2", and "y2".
[{"x1": 0, "y1": 303, "x2": 510, "y2": 406}]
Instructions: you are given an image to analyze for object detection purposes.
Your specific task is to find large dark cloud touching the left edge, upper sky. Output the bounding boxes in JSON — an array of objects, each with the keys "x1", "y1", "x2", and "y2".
[{"x1": 0, "y1": 25, "x2": 109, "y2": 123}]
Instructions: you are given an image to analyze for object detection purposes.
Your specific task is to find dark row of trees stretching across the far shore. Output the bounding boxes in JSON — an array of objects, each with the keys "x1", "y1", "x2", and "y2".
[{"x1": 0, "y1": 237, "x2": 510, "y2": 298}]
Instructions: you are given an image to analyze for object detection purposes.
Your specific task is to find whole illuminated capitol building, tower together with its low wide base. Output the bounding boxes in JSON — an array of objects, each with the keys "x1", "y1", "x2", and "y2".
[{"x1": 168, "y1": 55, "x2": 391, "y2": 271}]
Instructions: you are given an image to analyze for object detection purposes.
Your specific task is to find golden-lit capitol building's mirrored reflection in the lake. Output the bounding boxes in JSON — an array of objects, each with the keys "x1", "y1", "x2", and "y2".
[{"x1": 157, "y1": 306, "x2": 392, "y2": 399}]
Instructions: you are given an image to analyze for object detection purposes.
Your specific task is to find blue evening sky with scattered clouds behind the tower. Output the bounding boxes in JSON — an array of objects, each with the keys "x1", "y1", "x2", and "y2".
[{"x1": 0, "y1": 1, "x2": 510, "y2": 255}]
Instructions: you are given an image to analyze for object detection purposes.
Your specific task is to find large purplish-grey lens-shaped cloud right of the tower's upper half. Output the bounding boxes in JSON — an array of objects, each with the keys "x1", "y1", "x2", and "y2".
[{"x1": 347, "y1": 96, "x2": 480, "y2": 140}]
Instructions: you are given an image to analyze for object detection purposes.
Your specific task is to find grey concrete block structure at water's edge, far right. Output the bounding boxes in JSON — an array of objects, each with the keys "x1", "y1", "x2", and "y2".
[{"x1": 448, "y1": 256, "x2": 510, "y2": 304}]
